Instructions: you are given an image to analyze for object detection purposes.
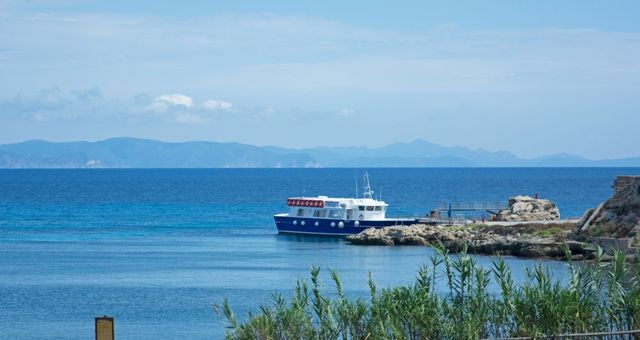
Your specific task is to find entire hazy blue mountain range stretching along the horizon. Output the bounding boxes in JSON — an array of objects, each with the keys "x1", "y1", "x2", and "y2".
[{"x1": 0, "y1": 138, "x2": 640, "y2": 168}]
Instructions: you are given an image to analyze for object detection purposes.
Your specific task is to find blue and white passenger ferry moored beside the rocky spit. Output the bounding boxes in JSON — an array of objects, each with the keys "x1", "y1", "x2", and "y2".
[{"x1": 273, "y1": 173, "x2": 417, "y2": 236}]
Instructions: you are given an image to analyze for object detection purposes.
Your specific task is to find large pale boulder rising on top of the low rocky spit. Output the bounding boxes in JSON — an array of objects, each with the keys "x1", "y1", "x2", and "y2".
[{"x1": 493, "y1": 196, "x2": 560, "y2": 222}]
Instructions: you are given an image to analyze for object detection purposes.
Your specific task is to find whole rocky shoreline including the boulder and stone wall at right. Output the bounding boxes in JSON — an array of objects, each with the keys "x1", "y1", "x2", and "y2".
[{"x1": 347, "y1": 176, "x2": 640, "y2": 261}]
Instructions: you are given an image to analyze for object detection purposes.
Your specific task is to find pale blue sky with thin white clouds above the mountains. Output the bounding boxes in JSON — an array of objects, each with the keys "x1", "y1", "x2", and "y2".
[{"x1": 0, "y1": 0, "x2": 640, "y2": 159}]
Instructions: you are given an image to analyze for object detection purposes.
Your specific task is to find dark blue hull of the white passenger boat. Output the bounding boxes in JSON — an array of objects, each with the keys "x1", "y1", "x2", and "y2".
[{"x1": 273, "y1": 215, "x2": 417, "y2": 236}]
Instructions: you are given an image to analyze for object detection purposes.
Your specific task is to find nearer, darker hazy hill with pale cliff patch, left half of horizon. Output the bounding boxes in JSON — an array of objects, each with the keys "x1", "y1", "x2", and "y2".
[{"x1": 0, "y1": 138, "x2": 315, "y2": 168}]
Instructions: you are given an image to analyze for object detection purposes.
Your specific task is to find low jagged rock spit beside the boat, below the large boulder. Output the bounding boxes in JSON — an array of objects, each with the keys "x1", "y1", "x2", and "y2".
[{"x1": 347, "y1": 223, "x2": 591, "y2": 260}]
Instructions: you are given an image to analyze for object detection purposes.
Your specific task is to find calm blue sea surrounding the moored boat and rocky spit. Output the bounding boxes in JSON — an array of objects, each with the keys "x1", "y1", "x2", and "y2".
[{"x1": 0, "y1": 168, "x2": 640, "y2": 339}]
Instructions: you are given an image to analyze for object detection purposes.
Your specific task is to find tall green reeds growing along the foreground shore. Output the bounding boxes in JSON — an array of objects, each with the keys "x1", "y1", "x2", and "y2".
[{"x1": 216, "y1": 247, "x2": 640, "y2": 340}]
